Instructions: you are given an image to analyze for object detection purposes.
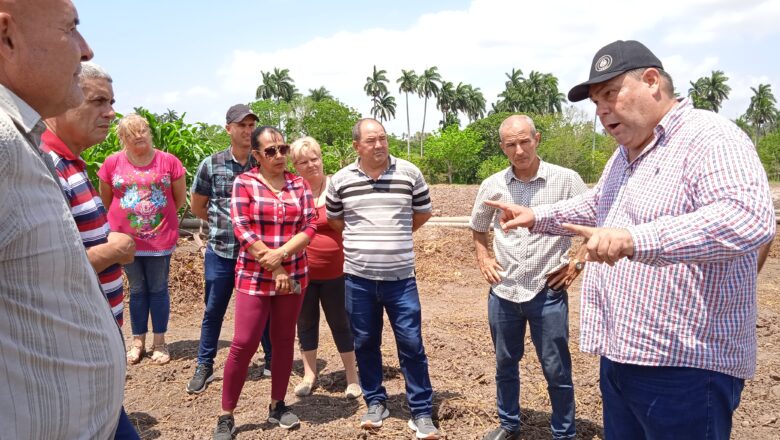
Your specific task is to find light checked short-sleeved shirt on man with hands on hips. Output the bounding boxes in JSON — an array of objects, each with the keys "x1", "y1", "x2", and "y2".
[{"x1": 469, "y1": 160, "x2": 588, "y2": 303}]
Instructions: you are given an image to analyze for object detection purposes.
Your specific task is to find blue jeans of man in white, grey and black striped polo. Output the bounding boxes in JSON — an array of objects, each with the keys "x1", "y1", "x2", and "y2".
[{"x1": 344, "y1": 274, "x2": 433, "y2": 417}]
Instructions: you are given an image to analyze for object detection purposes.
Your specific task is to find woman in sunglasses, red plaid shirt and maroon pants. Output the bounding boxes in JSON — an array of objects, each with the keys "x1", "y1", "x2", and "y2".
[{"x1": 214, "y1": 127, "x2": 316, "y2": 439}]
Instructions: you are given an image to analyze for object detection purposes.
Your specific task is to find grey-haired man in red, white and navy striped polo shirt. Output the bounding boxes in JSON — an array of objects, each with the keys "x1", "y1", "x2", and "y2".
[{"x1": 41, "y1": 62, "x2": 135, "y2": 326}]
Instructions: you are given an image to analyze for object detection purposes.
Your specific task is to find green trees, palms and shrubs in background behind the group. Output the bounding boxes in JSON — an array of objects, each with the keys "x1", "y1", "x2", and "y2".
[{"x1": 83, "y1": 65, "x2": 780, "y2": 195}]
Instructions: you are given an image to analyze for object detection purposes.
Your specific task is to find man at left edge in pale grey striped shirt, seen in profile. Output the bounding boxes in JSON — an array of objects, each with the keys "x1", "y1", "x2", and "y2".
[{"x1": 0, "y1": 0, "x2": 125, "y2": 440}]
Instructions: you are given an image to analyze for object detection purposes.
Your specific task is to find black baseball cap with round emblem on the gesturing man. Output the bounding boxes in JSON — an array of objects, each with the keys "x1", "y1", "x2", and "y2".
[{"x1": 569, "y1": 40, "x2": 664, "y2": 102}]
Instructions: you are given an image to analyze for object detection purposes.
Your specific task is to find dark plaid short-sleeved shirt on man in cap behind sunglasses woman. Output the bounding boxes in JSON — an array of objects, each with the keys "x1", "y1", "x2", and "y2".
[{"x1": 192, "y1": 147, "x2": 256, "y2": 260}]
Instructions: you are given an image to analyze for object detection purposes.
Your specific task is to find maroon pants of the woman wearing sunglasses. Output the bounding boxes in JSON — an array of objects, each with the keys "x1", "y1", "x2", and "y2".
[{"x1": 222, "y1": 291, "x2": 305, "y2": 411}]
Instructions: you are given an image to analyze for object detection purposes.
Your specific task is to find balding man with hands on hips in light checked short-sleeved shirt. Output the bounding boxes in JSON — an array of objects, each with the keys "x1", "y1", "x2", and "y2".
[{"x1": 470, "y1": 115, "x2": 587, "y2": 440}]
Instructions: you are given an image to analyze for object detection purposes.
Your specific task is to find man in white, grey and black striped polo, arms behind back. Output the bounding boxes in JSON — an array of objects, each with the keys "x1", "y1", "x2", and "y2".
[{"x1": 327, "y1": 119, "x2": 439, "y2": 439}]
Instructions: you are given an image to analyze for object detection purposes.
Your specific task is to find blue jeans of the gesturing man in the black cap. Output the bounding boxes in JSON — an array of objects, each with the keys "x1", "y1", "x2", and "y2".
[{"x1": 600, "y1": 357, "x2": 745, "y2": 440}]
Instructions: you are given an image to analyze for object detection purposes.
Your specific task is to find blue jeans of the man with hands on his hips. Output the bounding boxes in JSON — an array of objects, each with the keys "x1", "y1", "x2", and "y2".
[{"x1": 488, "y1": 287, "x2": 576, "y2": 439}]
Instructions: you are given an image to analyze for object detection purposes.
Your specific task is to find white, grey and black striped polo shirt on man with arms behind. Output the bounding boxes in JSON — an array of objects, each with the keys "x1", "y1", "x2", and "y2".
[{"x1": 326, "y1": 156, "x2": 431, "y2": 280}]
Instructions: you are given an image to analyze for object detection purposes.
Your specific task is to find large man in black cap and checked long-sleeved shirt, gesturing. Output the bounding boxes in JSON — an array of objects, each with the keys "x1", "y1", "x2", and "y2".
[{"x1": 486, "y1": 41, "x2": 775, "y2": 439}]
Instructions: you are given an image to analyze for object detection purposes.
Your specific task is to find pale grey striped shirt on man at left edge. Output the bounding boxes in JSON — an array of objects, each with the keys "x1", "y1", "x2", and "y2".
[{"x1": 0, "y1": 86, "x2": 126, "y2": 439}]
